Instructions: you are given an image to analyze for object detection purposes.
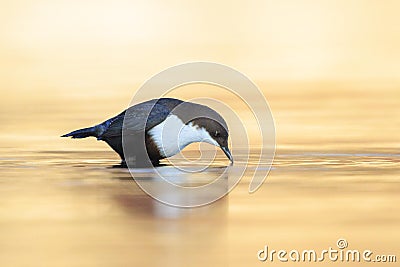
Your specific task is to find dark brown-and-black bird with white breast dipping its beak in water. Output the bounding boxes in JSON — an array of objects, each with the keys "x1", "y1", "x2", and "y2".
[{"x1": 61, "y1": 98, "x2": 233, "y2": 167}]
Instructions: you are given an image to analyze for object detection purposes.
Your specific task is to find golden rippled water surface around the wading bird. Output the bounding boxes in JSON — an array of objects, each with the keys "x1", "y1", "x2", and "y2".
[{"x1": 0, "y1": 89, "x2": 400, "y2": 267}]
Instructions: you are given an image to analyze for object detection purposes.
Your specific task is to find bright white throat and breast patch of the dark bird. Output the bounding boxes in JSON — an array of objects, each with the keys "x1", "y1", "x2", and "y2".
[{"x1": 148, "y1": 115, "x2": 219, "y2": 157}]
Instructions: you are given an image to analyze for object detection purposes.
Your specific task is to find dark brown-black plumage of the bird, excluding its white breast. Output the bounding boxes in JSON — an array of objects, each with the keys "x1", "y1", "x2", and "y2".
[{"x1": 62, "y1": 98, "x2": 232, "y2": 165}]
